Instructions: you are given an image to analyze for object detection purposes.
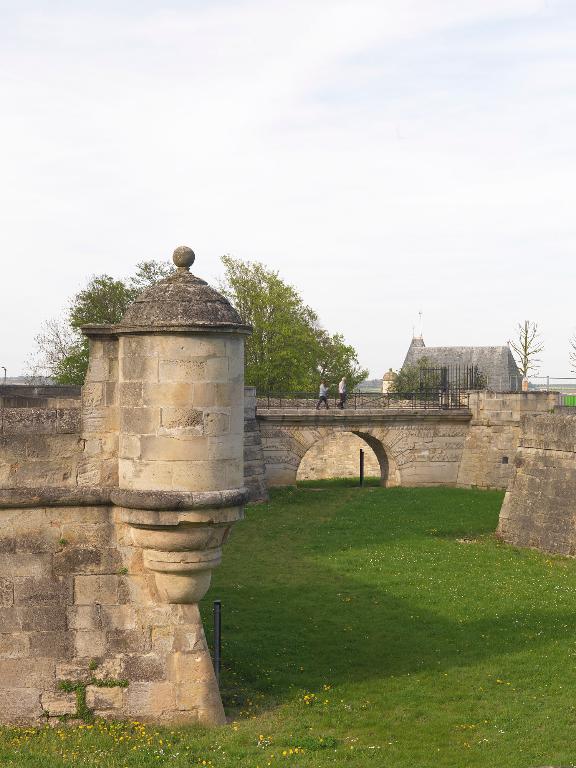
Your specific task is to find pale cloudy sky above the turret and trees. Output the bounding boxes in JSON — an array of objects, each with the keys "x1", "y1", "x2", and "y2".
[{"x1": 0, "y1": 0, "x2": 576, "y2": 377}]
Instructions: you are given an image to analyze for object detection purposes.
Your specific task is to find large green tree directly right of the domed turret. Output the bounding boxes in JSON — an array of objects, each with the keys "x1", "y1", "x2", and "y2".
[{"x1": 220, "y1": 256, "x2": 367, "y2": 393}]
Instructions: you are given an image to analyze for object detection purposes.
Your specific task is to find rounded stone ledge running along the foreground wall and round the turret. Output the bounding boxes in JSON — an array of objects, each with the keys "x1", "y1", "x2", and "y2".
[{"x1": 0, "y1": 487, "x2": 249, "y2": 511}]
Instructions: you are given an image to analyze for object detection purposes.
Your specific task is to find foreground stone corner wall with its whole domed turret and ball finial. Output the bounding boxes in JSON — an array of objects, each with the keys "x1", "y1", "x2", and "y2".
[{"x1": 0, "y1": 248, "x2": 250, "y2": 724}]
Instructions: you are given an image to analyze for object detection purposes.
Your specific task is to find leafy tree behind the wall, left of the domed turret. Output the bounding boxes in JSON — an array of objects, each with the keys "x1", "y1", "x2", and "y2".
[{"x1": 29, "y1": 261, "x2": 174, "y2": 384}]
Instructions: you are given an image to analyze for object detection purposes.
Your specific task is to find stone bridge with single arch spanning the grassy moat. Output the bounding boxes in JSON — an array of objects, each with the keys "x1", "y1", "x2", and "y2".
[{"x1": 256, "y1": 406, "x2": 472, "y2": 486}]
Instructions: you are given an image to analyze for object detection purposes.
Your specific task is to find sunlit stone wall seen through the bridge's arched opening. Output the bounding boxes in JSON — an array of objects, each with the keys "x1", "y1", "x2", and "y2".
[{"x1": 296, "y1": 432, "x2": 380, "y2": 480}]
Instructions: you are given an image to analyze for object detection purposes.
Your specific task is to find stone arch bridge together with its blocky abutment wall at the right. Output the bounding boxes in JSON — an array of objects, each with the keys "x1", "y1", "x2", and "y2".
[{"x1": 257, "y1": 391, "x2": 557, "y2": 489}]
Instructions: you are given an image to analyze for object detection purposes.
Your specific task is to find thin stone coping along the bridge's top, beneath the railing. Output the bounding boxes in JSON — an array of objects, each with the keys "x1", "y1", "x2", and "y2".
[{"x1": 256, "y1": 408, "x2": 472, "y2": 427}]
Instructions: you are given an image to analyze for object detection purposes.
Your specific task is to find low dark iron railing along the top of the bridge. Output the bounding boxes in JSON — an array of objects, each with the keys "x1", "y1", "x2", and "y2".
[{"x1": 256, "y1": 389, "x2": 469, "y2": 410}]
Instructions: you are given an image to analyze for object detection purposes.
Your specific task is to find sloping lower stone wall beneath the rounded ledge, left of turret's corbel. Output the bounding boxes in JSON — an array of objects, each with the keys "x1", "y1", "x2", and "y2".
[{"x1": 0, "y1": 507, "x2": 219, "y2": 723}]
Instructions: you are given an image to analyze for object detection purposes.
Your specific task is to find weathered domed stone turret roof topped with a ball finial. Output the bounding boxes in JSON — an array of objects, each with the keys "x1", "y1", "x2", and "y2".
[{"x1": 118, "y1": 246, "x2": 249, "y2": 331}]
